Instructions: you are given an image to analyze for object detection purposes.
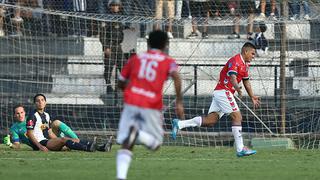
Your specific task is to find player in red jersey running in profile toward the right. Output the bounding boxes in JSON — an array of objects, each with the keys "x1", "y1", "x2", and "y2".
[{"x1": 171, "y1": 42, "x2": 260, "y2": 157}]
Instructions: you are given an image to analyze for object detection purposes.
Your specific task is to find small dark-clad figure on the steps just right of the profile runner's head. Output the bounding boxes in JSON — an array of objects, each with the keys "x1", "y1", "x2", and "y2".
[{"x1": 249, "y1": 22, "x2": 269, "y2": 56}]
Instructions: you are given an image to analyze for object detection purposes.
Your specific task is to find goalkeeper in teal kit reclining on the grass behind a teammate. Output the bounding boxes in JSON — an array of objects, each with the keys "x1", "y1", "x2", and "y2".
[{"x1": 3, "y1": 102, "x2": 112, "y2": 151}]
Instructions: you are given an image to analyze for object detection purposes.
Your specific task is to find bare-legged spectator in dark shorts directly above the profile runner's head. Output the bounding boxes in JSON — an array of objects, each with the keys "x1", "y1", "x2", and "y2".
[{"x1": 228, "y1": 1, "x2": 257, "y2": 39}]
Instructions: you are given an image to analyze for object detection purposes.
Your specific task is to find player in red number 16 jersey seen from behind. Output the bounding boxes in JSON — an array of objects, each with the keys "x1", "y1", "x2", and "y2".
[{"x1": 117, "y1": 30, "x2": 184, "y2": 179}]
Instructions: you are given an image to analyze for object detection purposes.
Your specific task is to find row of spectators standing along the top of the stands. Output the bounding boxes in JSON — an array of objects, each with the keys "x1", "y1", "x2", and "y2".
[{"x1": 0, "y1": 0, "x2": 310, "y2": 38}]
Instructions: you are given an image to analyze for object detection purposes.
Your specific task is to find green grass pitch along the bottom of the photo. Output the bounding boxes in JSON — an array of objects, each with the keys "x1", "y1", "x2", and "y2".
[{"x1": 0, "y1": 145, "x2": 320, "y2": 180}]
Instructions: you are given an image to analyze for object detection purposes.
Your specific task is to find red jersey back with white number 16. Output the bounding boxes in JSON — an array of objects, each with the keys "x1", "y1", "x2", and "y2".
[{"x1": 121, "y1": 50, "x2": 177, "y2": 109}]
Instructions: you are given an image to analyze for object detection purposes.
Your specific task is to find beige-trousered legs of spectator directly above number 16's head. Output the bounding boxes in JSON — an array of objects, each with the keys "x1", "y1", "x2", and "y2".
[{"x1": 154, "y1": 0, "x2": 175, "y2": 39}]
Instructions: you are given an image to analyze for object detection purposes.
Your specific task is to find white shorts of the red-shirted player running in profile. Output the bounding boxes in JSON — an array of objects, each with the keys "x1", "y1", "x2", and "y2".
[{"x1": 208, "y1": 90, "x2": 239, "y2": 117}]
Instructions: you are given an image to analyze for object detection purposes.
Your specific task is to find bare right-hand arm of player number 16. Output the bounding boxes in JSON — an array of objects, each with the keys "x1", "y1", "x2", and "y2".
[{"x1": 171, "y1": 71, "x2": 184, "y2": 119}]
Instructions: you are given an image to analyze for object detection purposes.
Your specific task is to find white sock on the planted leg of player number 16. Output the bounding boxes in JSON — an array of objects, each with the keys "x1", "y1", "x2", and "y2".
[{"x1": 117, "y1": 149, "x2": 132, "y2": 179}]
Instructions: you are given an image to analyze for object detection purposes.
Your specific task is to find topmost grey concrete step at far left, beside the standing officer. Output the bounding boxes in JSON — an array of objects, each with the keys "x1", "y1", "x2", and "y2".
[{"x1": 0, "y1": 36, "x2": 103, "y2": 56}]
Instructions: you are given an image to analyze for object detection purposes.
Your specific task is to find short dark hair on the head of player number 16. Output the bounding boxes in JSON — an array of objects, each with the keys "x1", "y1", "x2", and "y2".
[{"x1": 148, "y1": 30, "x2": 169, "y2": 49}]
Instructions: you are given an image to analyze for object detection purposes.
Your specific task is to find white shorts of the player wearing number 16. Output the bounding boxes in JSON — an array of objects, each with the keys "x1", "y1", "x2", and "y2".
[{"x1": 117, "y1": 104, "x2": 163, "y2": 144}]
